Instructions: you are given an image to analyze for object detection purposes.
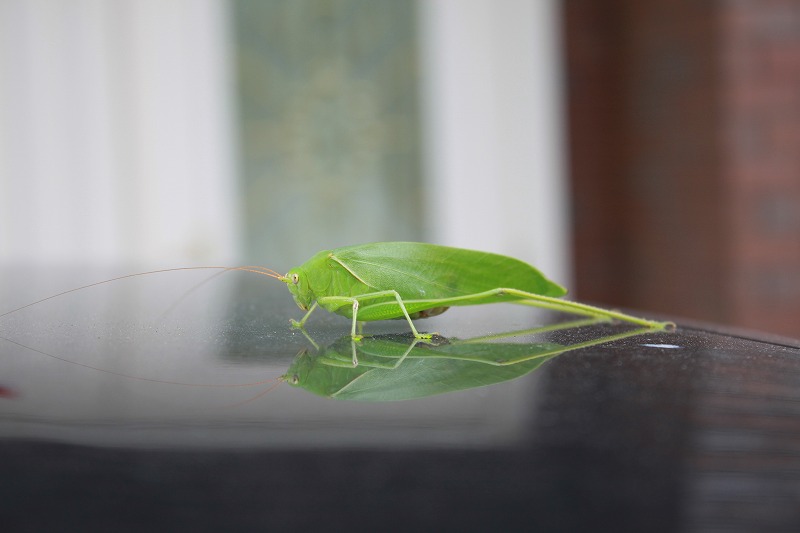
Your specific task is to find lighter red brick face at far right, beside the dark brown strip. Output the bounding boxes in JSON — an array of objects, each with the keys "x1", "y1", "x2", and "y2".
[{"x1": 720, "y1": 0, "x2": 800, "y2": 337}]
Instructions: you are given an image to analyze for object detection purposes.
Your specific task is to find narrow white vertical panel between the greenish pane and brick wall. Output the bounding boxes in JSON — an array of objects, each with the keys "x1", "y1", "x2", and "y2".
[{"x1": 419, "y1": 0, "x2": 570, "y2": 282}]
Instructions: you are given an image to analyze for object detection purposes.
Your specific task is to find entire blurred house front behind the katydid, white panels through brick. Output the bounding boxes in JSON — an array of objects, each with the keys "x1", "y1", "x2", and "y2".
[{"x1": 0, "y1": 0, "x2": 800, "y2": 337}]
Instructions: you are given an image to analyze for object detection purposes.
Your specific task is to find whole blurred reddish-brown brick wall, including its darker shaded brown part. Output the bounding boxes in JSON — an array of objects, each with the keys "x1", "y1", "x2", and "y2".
[{"x1": 565, "y1": 0, "x2": 800, "y2": 337}]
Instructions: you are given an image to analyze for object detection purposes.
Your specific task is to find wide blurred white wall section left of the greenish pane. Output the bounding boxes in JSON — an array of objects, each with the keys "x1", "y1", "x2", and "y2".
[{"x1": 0, "y1": 0, "x2": 237, "y2": 265}]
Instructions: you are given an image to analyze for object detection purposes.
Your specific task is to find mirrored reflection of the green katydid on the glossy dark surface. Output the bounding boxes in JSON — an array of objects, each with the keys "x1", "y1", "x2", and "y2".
[{"x1": 288, "y1": 318, "x2": 652, "y2": 402}]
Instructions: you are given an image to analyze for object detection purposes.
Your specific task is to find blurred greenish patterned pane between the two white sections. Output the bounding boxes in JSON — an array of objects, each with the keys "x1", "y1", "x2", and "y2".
[{"x1": 234, "y1": 0, "x2": 424, "y2": 270}]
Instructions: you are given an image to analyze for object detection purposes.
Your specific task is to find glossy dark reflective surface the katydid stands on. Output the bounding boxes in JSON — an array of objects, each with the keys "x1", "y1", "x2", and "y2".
[{"x1": 0, "y1": 269, "x2": 800, "y2": 531}]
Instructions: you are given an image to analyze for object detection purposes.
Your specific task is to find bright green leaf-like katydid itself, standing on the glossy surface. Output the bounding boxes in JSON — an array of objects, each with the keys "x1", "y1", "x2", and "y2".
[{"x1": 279, "y1": 242, "x2": 670, "y2": 339}]
